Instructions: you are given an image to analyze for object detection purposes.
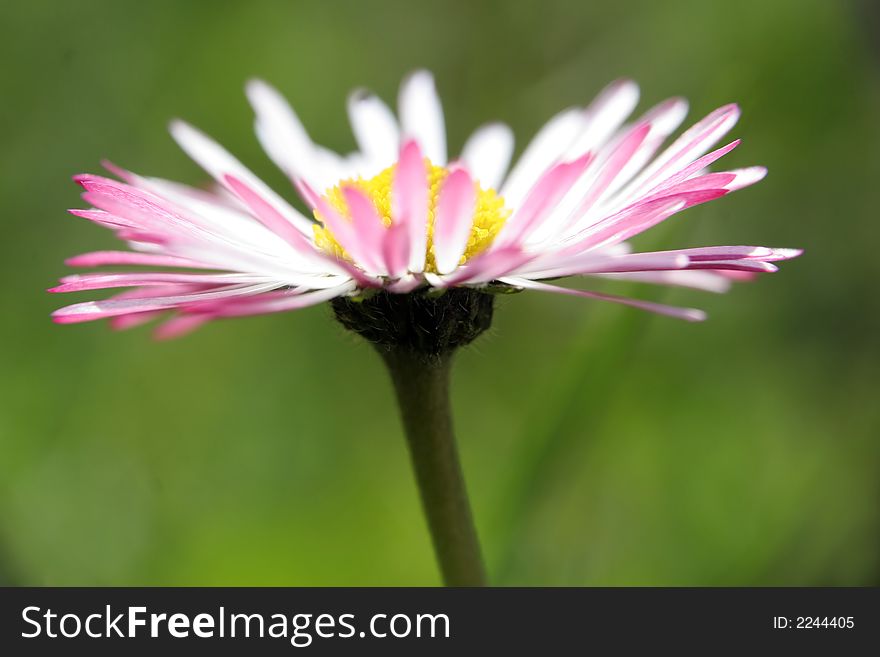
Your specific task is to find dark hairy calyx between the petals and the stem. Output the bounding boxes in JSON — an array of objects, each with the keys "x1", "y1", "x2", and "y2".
[{"x1": 331, "y1": 288, "x2": 494, "y2": 360}]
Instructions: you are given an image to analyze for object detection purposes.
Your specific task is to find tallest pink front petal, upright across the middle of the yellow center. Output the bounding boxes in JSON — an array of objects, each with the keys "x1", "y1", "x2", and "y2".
[{"x1": 391, "y1": 140, "x2": 428, "y2": 274}]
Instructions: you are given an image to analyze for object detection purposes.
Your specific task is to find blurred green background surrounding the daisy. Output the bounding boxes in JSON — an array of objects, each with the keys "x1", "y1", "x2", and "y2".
[{"x1": 0, "y1": 0, "x2": 880, "y2": 585}]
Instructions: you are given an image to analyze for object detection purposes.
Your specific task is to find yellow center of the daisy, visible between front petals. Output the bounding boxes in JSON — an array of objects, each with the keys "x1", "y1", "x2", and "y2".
[{"x1": 314, "y1": 159, "x2": 510, "y2": 273}]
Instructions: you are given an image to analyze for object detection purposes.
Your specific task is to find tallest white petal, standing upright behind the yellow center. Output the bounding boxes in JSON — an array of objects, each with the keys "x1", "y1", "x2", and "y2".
[{"x1": 398, "y1": 70, "x2": 446, "y2": 166}]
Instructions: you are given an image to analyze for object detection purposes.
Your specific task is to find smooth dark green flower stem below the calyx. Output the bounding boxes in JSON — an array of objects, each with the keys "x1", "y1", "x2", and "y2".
[{"x1": 379, "y1": 348, "x2": 486, "y2": 586}]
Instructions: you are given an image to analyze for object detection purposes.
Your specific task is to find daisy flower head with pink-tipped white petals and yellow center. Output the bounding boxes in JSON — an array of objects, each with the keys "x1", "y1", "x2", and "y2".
[{"x1": 52, "y1": 71, "x2": 800, "y2": 337}]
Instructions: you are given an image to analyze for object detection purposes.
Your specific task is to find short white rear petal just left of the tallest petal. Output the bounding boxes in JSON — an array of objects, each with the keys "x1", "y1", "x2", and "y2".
[{"x1": 348, "y1": 89, "x2": 400, "y2": 171}]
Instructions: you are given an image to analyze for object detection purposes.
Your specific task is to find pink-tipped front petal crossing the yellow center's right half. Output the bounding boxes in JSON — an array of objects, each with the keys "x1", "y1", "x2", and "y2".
[{"x1": 434, "y1": 169, "x2": 476, "y2": 274}]
